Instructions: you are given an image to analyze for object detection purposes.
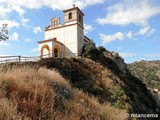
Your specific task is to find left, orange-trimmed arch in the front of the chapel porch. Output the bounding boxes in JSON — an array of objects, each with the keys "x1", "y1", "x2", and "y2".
[{"x1": 41, "y1": 45, "x2": 50, "y2": 58}]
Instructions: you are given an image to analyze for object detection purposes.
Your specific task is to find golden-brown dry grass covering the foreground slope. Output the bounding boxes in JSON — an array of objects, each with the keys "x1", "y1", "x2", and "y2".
[{"x1": 0, "y1": 66, "x2": 126, "y2": 120}]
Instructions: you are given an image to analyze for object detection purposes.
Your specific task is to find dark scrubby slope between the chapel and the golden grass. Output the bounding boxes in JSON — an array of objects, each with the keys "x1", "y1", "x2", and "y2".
[{"x1": 39, "y1": 58, "x2": 159, "y2": 118}]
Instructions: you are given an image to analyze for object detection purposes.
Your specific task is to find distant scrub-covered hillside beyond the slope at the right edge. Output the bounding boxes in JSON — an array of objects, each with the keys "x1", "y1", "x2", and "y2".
[{"x1": 128, "y1": 60, "x2": 160, "y2": 89}]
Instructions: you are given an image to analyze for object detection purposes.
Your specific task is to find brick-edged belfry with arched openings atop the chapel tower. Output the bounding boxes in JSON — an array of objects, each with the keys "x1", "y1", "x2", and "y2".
[{"x1": 63, "y1": 4, "x2": 84, "y2": 27}]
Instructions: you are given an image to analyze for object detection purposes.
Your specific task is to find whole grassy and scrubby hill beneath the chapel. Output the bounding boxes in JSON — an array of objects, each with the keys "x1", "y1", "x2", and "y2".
[{"x1": 0, "y1": 43, "x2": 160, "y2": 120}]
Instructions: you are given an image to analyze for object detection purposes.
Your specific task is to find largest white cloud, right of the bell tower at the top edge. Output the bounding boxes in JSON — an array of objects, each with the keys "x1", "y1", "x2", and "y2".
[{"x1": 97, "y1": 0, "x2": 160, "y2": 26}]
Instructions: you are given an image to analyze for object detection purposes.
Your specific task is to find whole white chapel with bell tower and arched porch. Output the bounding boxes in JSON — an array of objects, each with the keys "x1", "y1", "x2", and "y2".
[{"x1": 38, "y1": 5, "x2": 90, "y2": 58}]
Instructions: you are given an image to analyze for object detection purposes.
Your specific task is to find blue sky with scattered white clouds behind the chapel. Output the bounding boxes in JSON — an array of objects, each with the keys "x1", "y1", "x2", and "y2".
[{"x1": 0, "y1": 0, "x2": 160, "y2": 63}]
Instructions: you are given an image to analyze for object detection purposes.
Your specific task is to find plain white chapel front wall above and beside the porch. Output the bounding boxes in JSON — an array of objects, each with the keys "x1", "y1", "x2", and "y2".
[{"x1": 44, "y1": 24, "x2": 78, "y2": 54}]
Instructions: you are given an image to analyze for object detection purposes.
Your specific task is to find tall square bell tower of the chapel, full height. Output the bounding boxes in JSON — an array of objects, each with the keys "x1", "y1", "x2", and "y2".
[{"x1": 63, "y1": 5, "x2": 84, "y2": 56}]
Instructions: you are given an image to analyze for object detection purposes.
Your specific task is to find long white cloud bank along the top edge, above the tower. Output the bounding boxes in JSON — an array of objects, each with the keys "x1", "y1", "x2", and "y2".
[{"x1": 0, "y1": 0, "x2": 105, "y2": 10}]
